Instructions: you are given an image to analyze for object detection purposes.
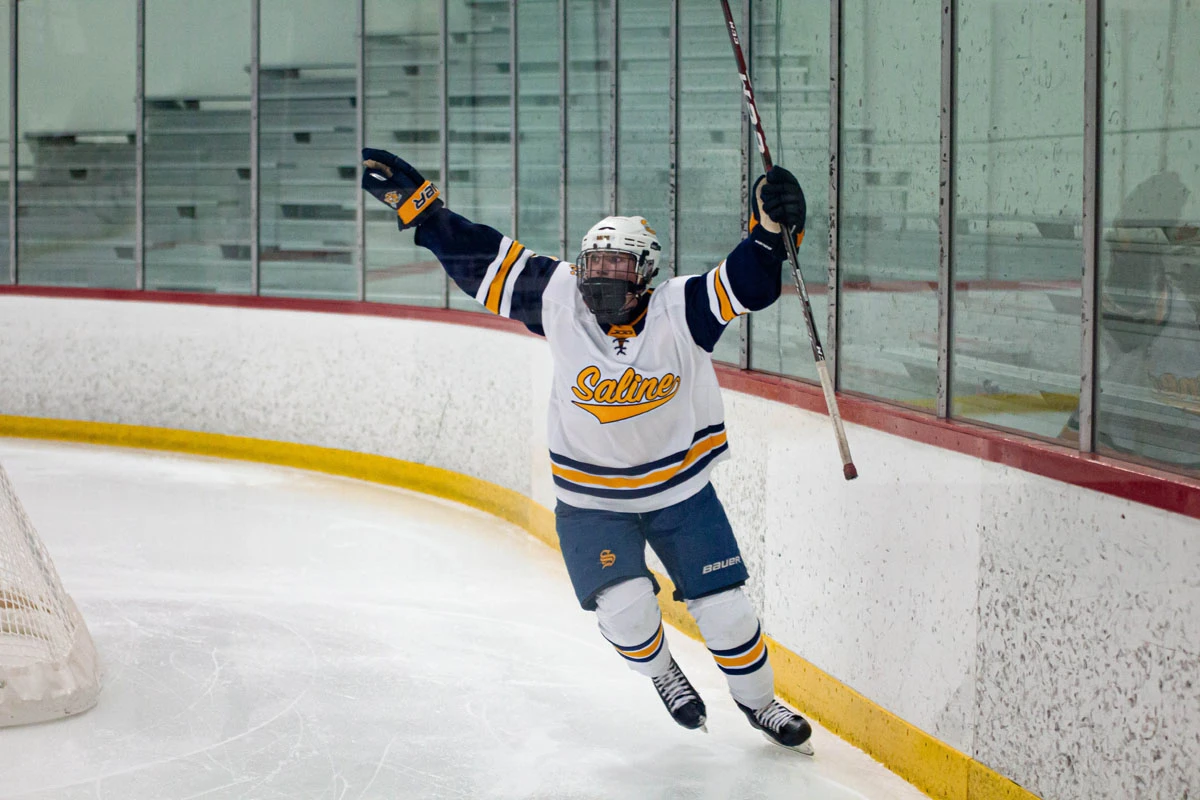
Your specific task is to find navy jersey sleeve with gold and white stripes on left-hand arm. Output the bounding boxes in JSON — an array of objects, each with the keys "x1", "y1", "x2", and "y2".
[{"x1": 416, "y1": 209, "x2": 562, "y2": 336}]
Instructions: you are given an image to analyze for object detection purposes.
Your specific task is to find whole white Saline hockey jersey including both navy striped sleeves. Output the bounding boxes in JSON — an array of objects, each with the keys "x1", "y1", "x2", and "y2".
[{"x1": 416, "y1": 209, "x2": 784, "y2": 512}]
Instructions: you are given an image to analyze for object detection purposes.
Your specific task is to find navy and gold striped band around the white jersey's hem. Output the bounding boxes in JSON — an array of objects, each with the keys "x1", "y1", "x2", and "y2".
[{"x1": 550, "y1": 422, "x2": 728, "y2": 499}]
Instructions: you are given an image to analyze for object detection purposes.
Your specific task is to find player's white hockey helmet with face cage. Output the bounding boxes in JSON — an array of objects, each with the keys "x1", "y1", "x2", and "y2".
[{"x1": 576, "y1": 217, "x2": 662, "y2": 321}]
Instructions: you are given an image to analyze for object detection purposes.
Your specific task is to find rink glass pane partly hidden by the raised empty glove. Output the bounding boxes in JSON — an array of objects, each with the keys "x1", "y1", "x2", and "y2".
[{"x1": 355, "y1": 0, "x2": 452, "y2": 306}]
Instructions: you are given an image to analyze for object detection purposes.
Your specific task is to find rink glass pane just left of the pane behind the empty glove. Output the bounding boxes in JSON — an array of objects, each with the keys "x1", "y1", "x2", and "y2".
[{"x1": 258, "y1": 0, "x2": 360, "y2": 297}]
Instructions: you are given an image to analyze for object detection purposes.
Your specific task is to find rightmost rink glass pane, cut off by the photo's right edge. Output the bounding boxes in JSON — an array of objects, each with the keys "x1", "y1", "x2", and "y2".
[{"x1": 1096, "y1": 2, "x2": 1200, "y2": 474}]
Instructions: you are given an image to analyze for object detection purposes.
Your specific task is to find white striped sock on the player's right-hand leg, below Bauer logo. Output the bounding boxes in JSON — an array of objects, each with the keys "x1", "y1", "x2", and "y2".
[{"x1": 688, "y1": 588, "x2": 775, "y2": 710}]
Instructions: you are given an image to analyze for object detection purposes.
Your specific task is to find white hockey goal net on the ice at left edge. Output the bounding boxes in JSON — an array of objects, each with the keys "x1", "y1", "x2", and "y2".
[{"x1": 0, "y1": 455, "x2": 100, "y2": 726}]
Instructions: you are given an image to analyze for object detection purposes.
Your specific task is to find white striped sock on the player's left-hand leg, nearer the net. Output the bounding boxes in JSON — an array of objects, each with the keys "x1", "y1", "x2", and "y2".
[{"x1": 596, "y1": 578, "x2": 671, "y2": 678}]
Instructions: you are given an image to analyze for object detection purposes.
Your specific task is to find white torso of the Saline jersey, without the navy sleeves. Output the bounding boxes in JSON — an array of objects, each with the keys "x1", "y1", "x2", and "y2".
[{"x1": 541, "y1": 264, "x2": 728, "y2": 511}]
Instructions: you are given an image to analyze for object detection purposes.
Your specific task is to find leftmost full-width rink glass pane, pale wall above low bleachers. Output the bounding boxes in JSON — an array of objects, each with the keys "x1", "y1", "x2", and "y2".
[{"x1": 16, "y1": 0, "x2": 137, "y2": 289}]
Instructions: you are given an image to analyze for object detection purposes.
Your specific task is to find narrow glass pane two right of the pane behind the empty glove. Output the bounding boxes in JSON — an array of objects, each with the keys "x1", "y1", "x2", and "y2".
[{"x1": 517, "y1": 0, "x2": 564, "y2": 258}]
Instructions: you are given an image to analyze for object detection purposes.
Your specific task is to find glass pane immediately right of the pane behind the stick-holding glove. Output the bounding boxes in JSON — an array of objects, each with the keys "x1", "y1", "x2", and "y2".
[{"x1": 835, "y1": 0, "x2": 941, "y2": 408}]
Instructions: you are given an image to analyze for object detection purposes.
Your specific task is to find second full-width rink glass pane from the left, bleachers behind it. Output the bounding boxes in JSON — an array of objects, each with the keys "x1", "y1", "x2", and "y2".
[{"x1": 144, "y1": 0, "x2": 251, "y2": 294}]
